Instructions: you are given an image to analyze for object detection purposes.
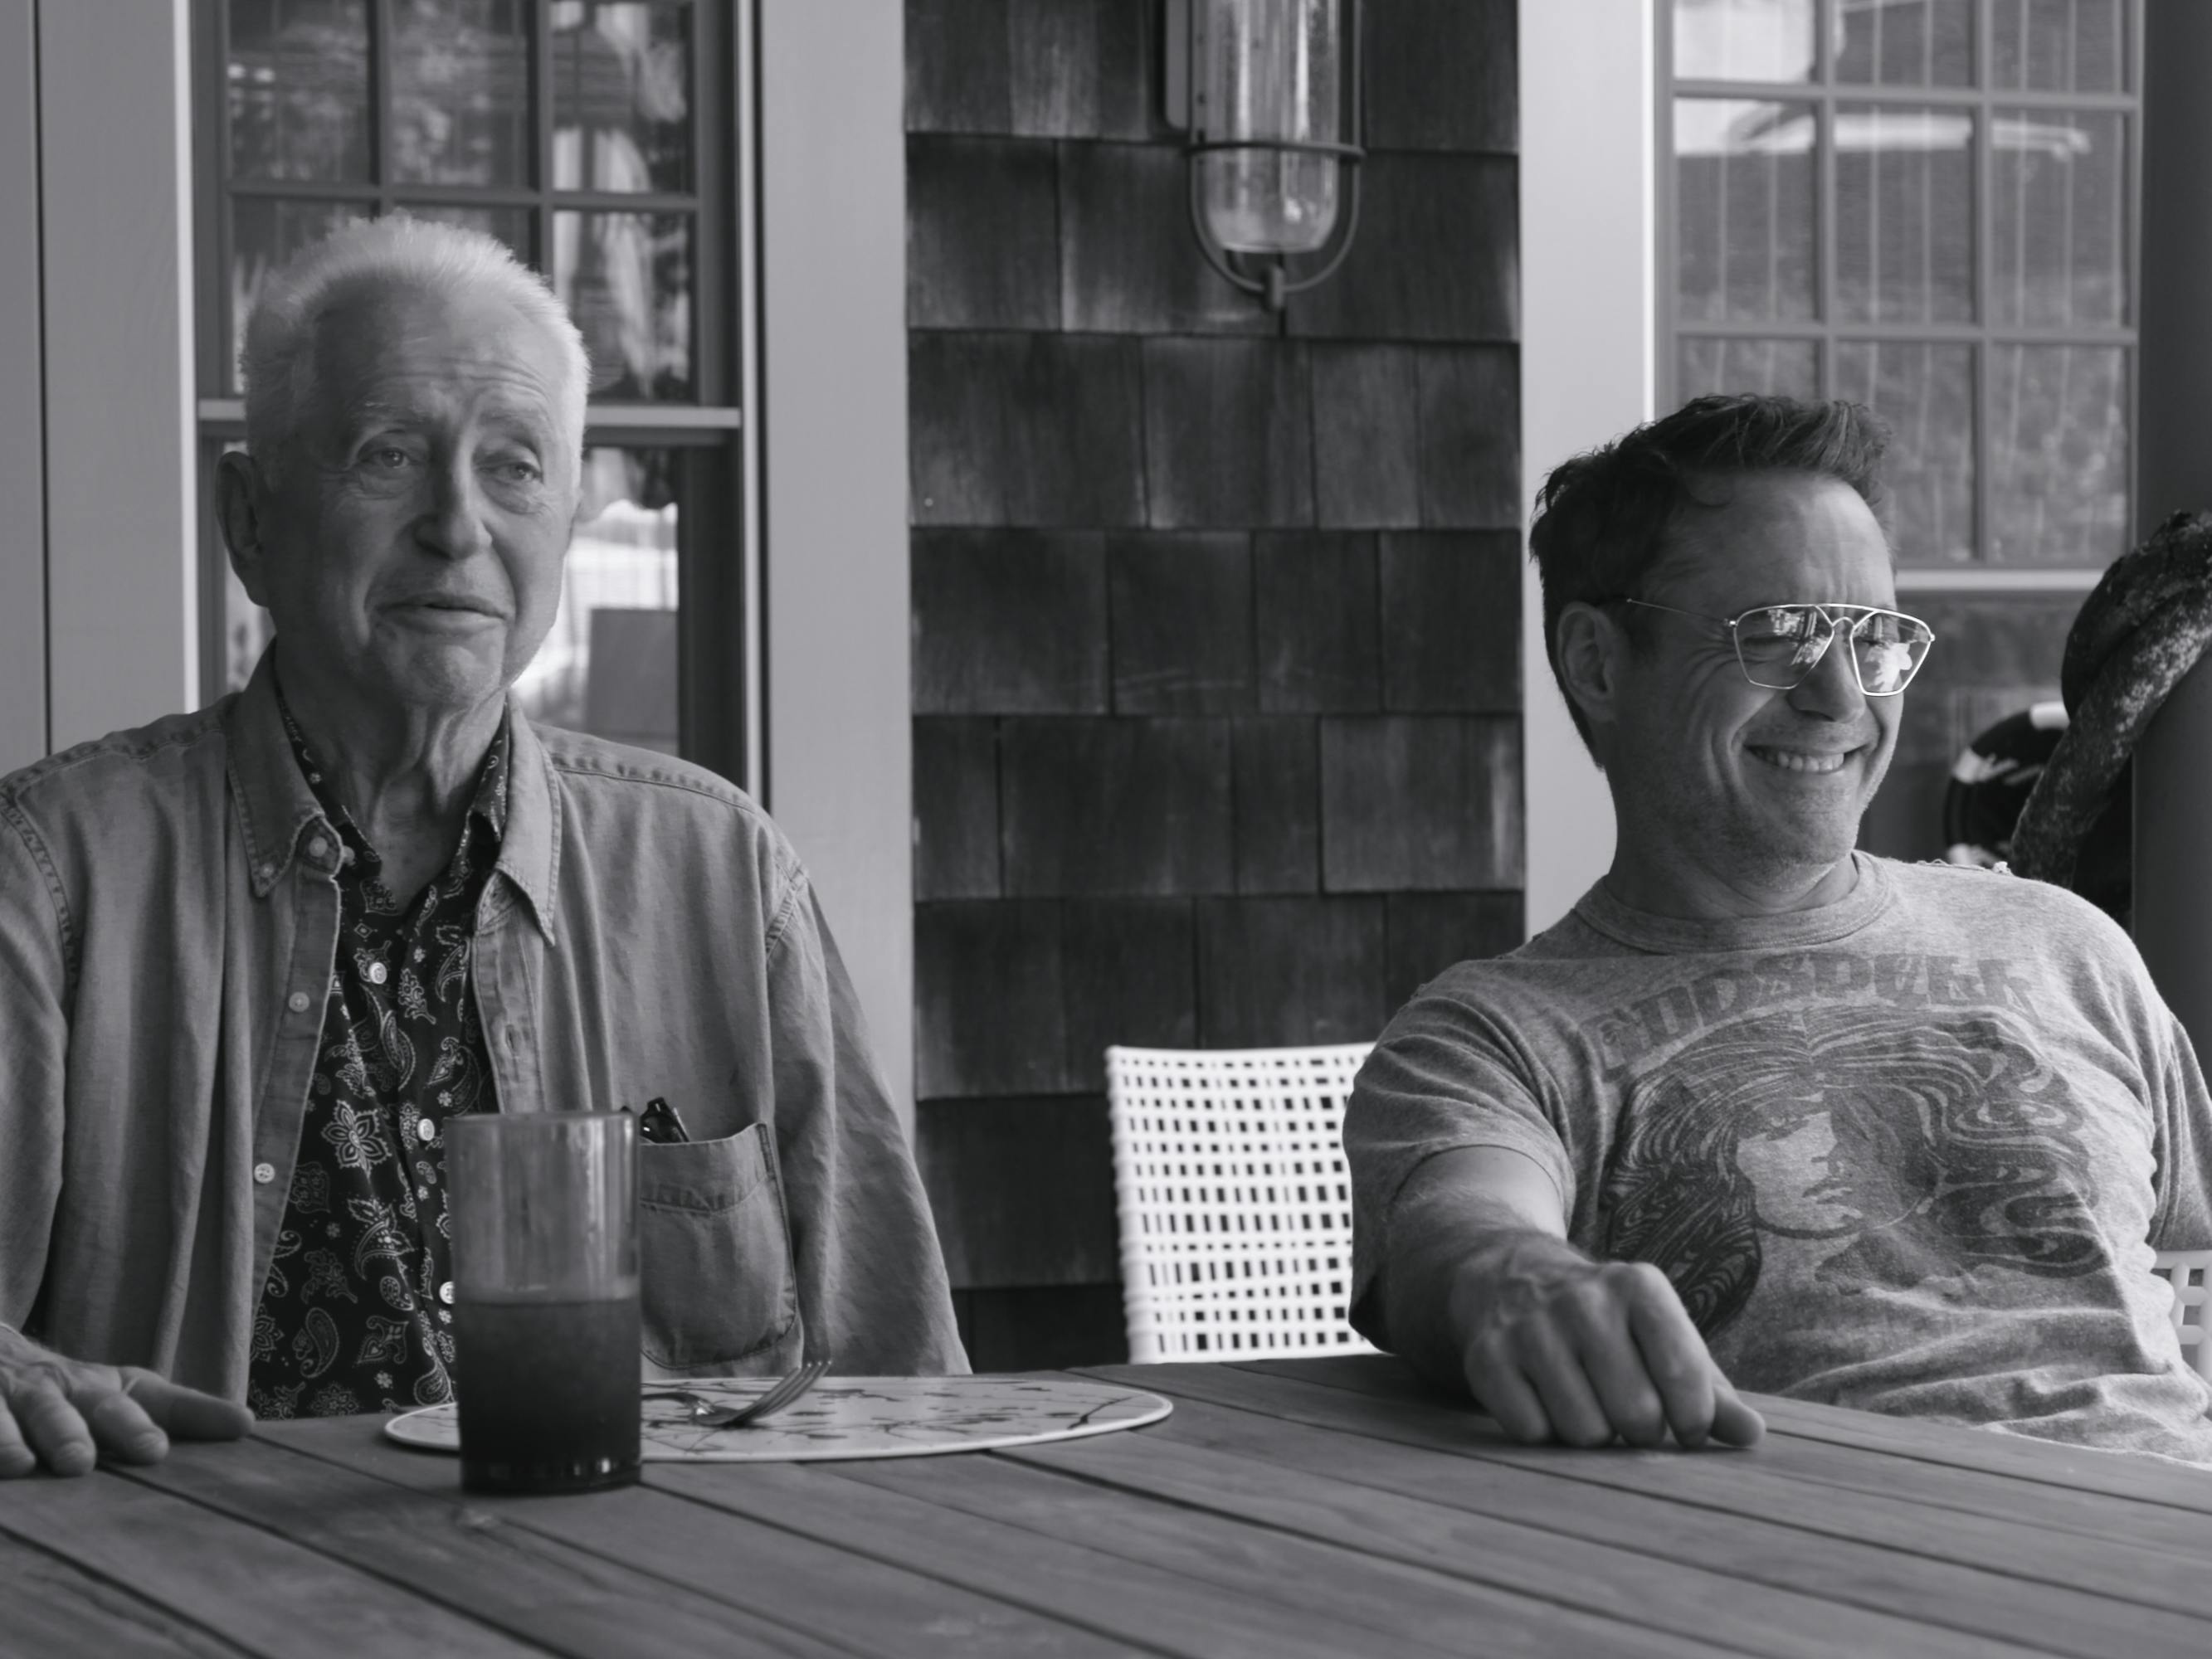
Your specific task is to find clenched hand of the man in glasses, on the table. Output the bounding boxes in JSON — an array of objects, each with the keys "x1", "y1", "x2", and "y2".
[{"x1": 1451, "y1": 1232, "x2": 1765, "y2": 1447}]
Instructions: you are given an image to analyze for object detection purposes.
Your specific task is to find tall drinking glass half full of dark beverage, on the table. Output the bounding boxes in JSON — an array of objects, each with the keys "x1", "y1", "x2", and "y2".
[{"x1": 447, "y1": 1112, "x2": 641, "y2": 1493}]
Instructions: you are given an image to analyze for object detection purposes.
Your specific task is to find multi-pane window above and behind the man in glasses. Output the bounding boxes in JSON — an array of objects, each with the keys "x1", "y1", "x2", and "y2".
[{"x1": 1659, "y1": 0, "x2": 2141, "y2": 571}]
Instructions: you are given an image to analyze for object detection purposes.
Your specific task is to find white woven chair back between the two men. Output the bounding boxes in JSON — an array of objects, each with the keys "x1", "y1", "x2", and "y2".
[{"x1": 1106, "y1": 1042, "x2": 1374, "y2": 1365}]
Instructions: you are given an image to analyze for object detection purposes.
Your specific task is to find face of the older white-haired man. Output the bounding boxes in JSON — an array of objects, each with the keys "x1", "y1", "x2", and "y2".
[{"x1": 232, "y1": 285, "x2": 577, "y2": 710}]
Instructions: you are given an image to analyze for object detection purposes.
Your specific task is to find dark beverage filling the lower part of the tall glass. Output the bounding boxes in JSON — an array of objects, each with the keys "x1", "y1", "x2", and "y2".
[{"x1": 454, "y1": 1281, "x2": 639, "y2": 1491}]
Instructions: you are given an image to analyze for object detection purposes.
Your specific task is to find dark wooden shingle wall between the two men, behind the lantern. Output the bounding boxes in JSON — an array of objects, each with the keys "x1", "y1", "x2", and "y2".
[{"x1": 907, "y1": 0, "x2": 1522, "y2": 1370}]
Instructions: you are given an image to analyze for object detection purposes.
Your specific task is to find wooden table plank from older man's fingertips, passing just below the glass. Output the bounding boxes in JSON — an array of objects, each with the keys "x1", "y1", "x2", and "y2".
[{"x1": 129, "y1": 1433, "x2": 845, "y2": 1659}]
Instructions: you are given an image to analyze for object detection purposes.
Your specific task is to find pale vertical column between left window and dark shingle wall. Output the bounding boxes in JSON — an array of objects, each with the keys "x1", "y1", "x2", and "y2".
[{"x1": 745, "y1": 0, "x2": 914, "y2": 1131}]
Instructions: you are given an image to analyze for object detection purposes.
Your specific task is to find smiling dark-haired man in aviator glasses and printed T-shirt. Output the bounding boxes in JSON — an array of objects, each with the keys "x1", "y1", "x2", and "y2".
[{"x1": 1345, "y1": 398, "x2": 2212, "y2": 1462}]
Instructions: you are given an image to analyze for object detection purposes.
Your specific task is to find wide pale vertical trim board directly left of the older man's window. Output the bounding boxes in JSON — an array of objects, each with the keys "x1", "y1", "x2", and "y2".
[{"x1": 37, "y1": 0, "x2": 199, "y2": 747}]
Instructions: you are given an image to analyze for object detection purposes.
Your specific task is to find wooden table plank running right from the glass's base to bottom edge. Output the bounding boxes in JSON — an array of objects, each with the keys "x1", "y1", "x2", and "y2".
[{"x1": 646, "y1": 1462, "x2": 1566, "y2": 1659}]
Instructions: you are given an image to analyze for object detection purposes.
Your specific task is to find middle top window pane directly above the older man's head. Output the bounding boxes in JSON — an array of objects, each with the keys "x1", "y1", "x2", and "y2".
[{"x1": 392, "y1": 0, "x2": 531, "y2": 186}]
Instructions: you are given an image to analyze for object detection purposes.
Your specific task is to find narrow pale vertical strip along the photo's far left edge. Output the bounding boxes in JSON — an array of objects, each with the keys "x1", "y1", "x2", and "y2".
[{"x1": 0, "y1": 0, "x2": 46, "y2": 776}]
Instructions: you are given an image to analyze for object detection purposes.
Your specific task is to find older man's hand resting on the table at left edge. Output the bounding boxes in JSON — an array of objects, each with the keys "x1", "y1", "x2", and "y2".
[{"x1": 0, "y1": 1325, "x2": 255, "y2": 1480}]
